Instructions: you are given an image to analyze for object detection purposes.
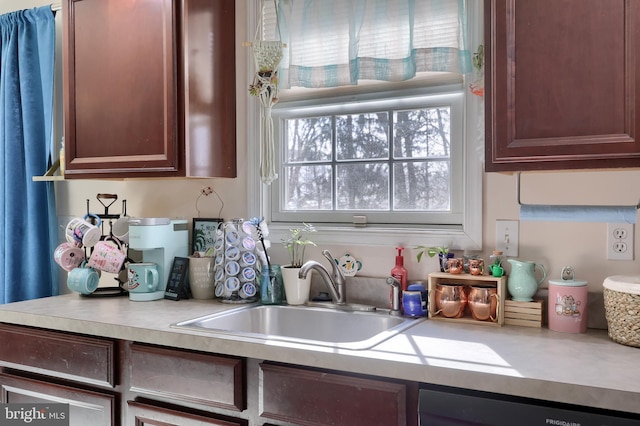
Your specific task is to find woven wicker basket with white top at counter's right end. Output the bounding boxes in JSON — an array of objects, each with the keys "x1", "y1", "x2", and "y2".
[{"x1": 604, "y1": 277, "x2": 640, "y2": 347}]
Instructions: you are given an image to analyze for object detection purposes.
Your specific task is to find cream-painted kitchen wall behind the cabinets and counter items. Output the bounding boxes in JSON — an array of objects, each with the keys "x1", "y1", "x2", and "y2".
[{"x1": 5, "y1": 0, "x2": 640, "y2": 304}]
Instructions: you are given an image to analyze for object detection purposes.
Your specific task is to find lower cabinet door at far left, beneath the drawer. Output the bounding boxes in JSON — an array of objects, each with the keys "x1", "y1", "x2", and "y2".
[{"x1": 0, "y1": 374, "x2": 115, "y2": 426}]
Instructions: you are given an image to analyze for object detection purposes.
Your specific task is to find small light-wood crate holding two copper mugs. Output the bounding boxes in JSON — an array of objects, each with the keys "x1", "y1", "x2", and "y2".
[{"x1": 428, "y1": 272, "x2": 507, "y2": 326}]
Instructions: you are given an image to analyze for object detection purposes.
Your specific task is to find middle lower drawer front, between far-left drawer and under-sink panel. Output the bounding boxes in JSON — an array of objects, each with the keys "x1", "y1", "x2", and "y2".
[{"x1": 129, "y1": 343, "x2": 247, "y2": 411}]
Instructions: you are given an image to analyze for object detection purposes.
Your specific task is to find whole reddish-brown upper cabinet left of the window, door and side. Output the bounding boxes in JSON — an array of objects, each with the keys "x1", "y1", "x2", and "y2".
[{"x1": 63, "y1": 0, "x2": 236, "y2": 178}]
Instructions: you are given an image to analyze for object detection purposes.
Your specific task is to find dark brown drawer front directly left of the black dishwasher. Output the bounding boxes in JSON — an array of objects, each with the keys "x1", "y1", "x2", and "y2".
[{"x1": 260, "y1": 362, "x2": 415, "y2": 426}]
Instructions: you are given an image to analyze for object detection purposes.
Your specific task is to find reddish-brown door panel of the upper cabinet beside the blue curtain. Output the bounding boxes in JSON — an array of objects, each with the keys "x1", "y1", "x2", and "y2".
[{"x1": 64, "y1": 0, "x2": 180, "y2": 177}]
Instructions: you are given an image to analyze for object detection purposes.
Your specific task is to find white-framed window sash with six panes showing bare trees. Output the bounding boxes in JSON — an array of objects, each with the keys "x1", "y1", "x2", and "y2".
[{"x1": 271, "y1": 88, "x2": 463, "y2": 226}]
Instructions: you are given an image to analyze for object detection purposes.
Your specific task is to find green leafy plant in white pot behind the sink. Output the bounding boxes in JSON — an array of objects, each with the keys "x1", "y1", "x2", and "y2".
[{"x1": 282, "y1": 222, "x2": 316, "y2": 305}]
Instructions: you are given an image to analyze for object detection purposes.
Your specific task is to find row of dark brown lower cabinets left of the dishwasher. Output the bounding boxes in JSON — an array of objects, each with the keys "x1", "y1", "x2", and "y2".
[{"x1": 0, "y1": 323, "x2": 418, "y2": 426}]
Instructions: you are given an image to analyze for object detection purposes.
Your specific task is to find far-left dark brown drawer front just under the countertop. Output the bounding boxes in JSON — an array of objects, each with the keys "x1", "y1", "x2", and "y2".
[{"x1": 0, "y1": 324, "x2": 116, "y2": 387}]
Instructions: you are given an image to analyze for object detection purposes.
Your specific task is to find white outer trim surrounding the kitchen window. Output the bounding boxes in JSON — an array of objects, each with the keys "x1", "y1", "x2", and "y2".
[{"x1": 244, "y1": 2, "x2": 484, "y2": 251}]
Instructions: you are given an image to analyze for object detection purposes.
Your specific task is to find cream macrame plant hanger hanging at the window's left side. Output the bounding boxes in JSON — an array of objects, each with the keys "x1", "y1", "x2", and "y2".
[{"x1": 249, "y1": 0, "x2": 285, "y2": 185}]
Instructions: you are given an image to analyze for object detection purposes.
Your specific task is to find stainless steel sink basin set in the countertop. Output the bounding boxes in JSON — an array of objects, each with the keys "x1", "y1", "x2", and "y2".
[{"x1": 171, "y1": 305, "x2": 420, "y2": 350}]
